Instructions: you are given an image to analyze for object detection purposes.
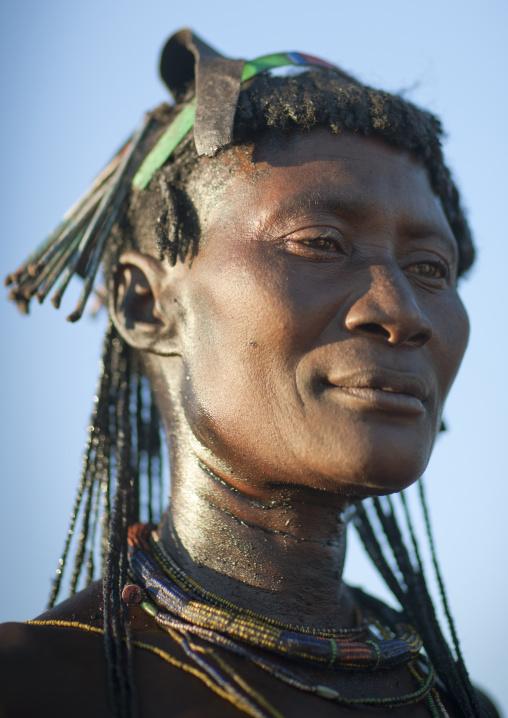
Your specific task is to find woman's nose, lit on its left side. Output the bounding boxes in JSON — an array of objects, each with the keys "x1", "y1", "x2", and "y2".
[{"x1": 345, "y1": 265, "x2": 433, "y2": 347}]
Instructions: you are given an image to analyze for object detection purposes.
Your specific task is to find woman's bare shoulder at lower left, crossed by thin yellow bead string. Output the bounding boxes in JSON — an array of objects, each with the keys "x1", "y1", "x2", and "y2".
[{"x1": 0, "y1": 583, "x2": 241, "y2": 718}]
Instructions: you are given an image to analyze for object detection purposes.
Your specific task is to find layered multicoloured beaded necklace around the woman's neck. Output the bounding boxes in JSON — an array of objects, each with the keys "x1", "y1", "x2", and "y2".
[{"x1": 122, "y1": 524, "x2": 447, "y2": 718}]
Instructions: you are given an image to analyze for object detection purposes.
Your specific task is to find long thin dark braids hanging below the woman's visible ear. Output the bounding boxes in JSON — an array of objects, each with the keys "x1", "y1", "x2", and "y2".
[{"x1": 45, "y1": 324, "x2": 162, "y2": 718}]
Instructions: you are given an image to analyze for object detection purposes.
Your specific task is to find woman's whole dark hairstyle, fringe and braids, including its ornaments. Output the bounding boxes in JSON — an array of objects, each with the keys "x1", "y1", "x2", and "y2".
[{"x1": 7, "y1": 30, "x2": 482, "y2": 717}]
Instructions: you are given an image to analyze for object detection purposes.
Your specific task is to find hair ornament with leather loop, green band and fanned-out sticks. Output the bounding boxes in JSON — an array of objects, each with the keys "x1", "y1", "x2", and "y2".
[{"x1": 5, "y1": 28, "x2": 335, "y2": 322}]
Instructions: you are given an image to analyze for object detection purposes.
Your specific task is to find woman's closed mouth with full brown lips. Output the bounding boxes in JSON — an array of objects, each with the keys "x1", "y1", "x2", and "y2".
[{"x1": 324, "y1": 369, "x2": 429, "y2": 414}]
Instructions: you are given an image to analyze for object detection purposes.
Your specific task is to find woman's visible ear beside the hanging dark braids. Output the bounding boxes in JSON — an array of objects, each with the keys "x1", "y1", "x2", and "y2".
[{"x1": 109, "y1": 251, "x2": 180, "y2": 356}]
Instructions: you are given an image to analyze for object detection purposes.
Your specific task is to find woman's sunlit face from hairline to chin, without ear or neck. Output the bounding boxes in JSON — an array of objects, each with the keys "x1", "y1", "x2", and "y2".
[{"x1": 172, "y1": 129, "x2": 468, "y2": 496}]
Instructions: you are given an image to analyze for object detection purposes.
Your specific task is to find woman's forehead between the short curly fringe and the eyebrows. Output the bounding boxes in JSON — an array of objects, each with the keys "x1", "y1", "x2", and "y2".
[{"x1": 193, "y1": 128, "x2": 452, "y2": 242}]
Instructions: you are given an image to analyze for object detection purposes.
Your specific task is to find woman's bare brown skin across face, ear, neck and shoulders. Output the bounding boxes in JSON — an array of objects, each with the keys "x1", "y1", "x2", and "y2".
[{"x1": 3, "y1": 129, "x2": 476, "y2": 718}]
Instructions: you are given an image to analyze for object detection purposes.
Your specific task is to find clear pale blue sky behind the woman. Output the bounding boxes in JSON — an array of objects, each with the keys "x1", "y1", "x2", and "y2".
[{"x1": 0, "y1": 0, "x2": 508, "y2": 713}]
